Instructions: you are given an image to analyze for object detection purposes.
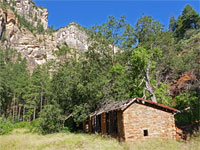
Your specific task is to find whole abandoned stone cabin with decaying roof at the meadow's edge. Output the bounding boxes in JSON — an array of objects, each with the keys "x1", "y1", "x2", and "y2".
[{"x1": 83, "y1": 97, "x2": 178, "y2": 143}]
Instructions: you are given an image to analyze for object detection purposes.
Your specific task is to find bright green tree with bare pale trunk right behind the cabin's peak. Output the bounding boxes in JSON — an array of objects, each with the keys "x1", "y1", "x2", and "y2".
[{"x1": 131, "y1": 47, "x2": 161, "y2": 102}]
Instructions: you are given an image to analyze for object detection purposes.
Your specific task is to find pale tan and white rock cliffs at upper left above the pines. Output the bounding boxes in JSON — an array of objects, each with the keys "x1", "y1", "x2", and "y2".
[{"x1": 0, "y1": 0, "x2": 88, "y2": 70}]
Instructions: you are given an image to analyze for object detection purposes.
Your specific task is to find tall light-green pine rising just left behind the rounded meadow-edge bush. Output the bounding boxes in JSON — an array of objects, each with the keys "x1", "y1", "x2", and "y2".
[{"x1": 23, "y1": 65, "x2": 52, "y2": 120}]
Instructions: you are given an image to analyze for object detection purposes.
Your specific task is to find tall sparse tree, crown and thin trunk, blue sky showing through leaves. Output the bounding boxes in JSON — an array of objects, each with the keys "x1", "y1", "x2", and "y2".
[{"x1": 90, "y1": 16, "x2": 136, "y2": 65}]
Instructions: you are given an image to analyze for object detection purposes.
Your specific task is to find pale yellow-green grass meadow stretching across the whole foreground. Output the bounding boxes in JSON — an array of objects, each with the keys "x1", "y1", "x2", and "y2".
[{"x1": 0, "y1": 129, "x2": 200, "y2": 150}]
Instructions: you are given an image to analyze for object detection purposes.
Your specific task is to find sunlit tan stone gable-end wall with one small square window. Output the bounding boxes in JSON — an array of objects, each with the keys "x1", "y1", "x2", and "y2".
[{"x1": 123, "y1": 103, "x2": 176, "y2": 143}]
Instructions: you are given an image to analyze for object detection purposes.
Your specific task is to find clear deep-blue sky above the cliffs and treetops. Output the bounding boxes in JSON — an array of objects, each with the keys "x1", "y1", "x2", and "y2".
[{"x1": 33, "y1": 0, "x2": 200, "y2": 29}]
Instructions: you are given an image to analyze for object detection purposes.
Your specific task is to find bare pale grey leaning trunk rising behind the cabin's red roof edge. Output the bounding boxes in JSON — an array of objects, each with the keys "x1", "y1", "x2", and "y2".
[{"x1": 145, "y1": 61, "x2": 157, "y2": 103}]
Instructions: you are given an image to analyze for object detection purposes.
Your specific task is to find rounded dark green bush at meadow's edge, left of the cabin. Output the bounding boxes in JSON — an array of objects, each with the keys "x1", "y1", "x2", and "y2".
[{"x1": 38, "y1": 104, "x2": 62, "y2": 134}]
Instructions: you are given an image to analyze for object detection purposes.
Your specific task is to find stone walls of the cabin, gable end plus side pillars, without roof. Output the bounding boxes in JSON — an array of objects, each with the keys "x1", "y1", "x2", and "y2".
[{"x1": 84, "y1": 103, "x2": 176, "y2": 143}]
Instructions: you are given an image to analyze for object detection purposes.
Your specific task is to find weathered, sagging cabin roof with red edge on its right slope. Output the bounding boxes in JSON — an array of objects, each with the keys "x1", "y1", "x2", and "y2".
[{"x1": 90, "y1": 97, "x2": 179, "y2": 117}]
